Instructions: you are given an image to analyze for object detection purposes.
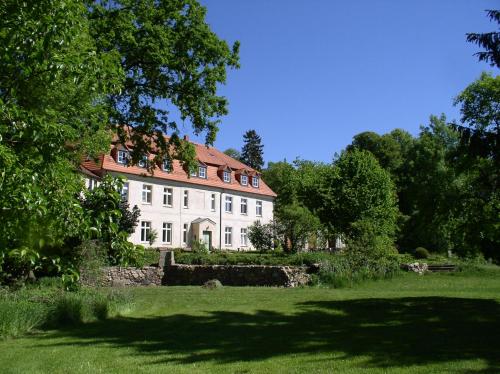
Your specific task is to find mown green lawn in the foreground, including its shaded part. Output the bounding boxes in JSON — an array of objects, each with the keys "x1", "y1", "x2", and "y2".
[{"x1": 0, "y1": 272, "x2": 500, "y2": 373}]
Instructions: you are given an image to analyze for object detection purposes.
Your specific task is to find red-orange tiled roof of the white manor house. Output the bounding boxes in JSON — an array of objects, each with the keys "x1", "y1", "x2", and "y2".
[{"x1": 83, "y1": 135, "x2": 276, "y2": 197}]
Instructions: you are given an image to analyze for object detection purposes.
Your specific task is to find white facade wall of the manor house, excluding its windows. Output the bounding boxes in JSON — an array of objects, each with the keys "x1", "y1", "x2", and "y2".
[{"x1": 111, "y1": 173, "x2": 273, "y2": 250}]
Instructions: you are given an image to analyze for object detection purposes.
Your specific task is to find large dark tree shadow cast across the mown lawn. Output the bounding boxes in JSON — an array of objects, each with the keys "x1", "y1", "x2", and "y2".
[{"x1": 33, "y1": 297, "x2": 500, "y2": 372}]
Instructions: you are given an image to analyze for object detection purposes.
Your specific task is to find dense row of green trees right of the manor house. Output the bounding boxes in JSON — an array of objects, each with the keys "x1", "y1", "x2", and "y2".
[{"x1": 264, "y1": 74, "x2": 500, "y2": 261}]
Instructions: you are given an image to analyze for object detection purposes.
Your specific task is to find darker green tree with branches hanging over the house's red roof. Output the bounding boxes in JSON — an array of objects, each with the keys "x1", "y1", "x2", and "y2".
[{"x1": 86, "y1": 0, "x2": 239, "y2": 167}]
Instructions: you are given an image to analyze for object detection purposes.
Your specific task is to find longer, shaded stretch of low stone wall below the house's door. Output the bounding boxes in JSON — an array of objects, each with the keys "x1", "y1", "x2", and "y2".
[{"x1": 161, "y1": 252, "x2": 310, "y2": 287}]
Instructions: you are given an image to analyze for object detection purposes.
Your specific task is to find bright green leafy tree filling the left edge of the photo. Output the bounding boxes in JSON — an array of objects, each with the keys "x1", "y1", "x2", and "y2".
[{"x1": 0, "y1": 0, "x2": 122, "y2": 251}]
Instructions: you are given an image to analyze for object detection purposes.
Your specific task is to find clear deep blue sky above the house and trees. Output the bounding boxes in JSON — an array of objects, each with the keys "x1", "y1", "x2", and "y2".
[{"x1": 186, "y1": 0, "x2": 500, "y2": 162}]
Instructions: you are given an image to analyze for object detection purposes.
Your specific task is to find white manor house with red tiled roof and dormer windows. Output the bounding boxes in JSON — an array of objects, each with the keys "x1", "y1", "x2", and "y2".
[{"x1": 81, "y1": 135, "x2": 276, "y2": 250}]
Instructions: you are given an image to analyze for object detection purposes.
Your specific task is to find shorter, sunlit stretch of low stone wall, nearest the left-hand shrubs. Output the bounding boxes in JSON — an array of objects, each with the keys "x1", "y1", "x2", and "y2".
[{"x1": 81, "y1": 266, "x2": 163, "y2": 287}]
